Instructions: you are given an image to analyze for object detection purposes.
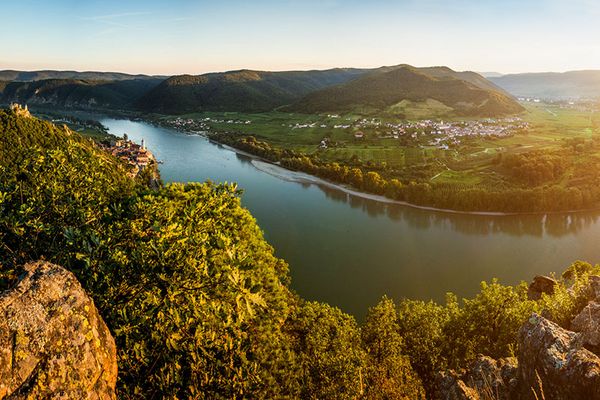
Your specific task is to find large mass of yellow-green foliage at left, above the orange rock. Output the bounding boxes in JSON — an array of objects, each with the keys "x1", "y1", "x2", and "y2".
[{"x1": 0, "y1": 108, "x2": 293, "y2": 398}]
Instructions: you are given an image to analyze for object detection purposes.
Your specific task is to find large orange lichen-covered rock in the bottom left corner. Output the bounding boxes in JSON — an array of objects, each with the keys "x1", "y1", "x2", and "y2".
[{"x1": 0, "y1": 262, "x2": 117, "y2": 399}]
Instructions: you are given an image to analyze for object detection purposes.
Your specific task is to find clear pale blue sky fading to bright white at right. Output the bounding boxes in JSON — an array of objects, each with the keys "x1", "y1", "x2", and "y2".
[{"x1": 0, "y1": 0, "x2": 600, "y2": 75}]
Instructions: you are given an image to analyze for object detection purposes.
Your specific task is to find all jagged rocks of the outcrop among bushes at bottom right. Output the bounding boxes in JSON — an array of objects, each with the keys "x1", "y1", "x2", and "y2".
[{"x1": 435, "y1": 276, "x2": 600, "y2": 400}]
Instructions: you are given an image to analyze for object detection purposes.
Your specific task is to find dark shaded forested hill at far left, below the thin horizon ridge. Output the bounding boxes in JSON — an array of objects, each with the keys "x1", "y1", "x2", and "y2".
[{"x1": 0, "y1": 78, "x2": 162, "y2": 109}]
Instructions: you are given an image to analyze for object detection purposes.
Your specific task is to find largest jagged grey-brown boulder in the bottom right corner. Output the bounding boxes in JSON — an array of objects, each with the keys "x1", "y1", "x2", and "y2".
[{"x1": 518, "y1": 314, "x2": 600, "y2": 400}]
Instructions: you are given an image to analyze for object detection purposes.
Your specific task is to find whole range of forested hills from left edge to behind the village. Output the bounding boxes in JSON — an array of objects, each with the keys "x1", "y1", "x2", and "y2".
[{"x1": 0, "y1": 65, "x2": 522, "y2": 117}]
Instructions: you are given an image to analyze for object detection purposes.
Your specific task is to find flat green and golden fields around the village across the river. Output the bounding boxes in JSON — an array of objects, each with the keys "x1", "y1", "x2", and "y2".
[{"x1": 154, "y1": 103, "x2": 600, "y2": 185}]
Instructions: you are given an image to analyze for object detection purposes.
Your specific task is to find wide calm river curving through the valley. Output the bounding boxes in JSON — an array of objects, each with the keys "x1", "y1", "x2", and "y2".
[{"x1": 101, "y1": 118, "x2": 600, "y2": 319}]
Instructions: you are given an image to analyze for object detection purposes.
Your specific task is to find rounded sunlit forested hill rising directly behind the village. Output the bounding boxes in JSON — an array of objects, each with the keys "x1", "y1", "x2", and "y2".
[{"x1": 287, "y1": 65, "x2": 523, "y2": 118}]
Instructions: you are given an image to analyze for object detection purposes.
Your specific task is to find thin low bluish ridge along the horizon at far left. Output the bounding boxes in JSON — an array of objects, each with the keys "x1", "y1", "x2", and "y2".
[{"x1": 0, "y1": 70, "x2": 167, "y2": 82}]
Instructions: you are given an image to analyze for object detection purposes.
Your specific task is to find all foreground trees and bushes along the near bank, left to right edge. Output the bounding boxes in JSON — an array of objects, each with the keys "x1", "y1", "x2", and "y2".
[{"x1": 0, "y1": 111, "x2": 598, "y2": 399}]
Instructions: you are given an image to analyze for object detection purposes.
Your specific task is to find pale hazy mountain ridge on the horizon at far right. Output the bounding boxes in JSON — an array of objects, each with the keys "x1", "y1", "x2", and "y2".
[{"x1": 490, "y1": 70, "x2": 600, "y2": 99}]
